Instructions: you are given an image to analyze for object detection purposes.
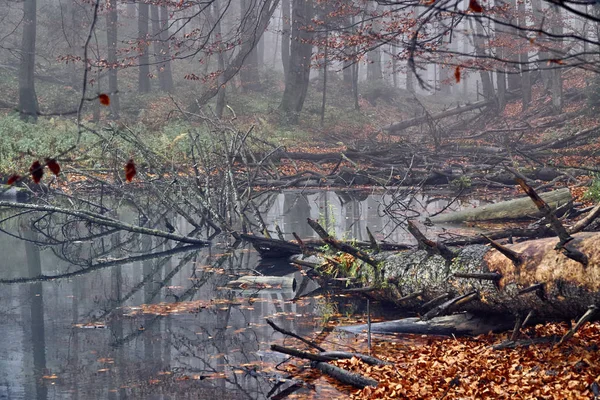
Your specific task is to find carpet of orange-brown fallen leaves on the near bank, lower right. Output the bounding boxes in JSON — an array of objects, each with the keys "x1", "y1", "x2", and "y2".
[{"x1": 326, "y1": 323, "x2": 600, "y2": 399}]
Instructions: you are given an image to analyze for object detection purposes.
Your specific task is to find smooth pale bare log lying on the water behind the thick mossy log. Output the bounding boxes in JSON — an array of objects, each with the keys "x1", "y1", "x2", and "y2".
[{"x1": 430, "y1": 188, "x2": 572, "y2": 223}]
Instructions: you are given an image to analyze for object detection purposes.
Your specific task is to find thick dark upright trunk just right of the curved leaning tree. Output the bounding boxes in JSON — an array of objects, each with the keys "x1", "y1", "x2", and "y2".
[{"x1": 279, "y1": 0, "x2": 313, "y2": 124}]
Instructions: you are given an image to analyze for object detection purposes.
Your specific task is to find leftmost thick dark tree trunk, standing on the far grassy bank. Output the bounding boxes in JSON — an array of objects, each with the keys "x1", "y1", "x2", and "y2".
[{"x1": 19, "y1": 0, "x2": 38, "y2": 122}]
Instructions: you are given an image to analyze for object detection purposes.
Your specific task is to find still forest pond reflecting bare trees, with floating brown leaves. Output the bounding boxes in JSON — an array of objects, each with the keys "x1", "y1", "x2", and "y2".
[{"x1": 0, "y1": 191, "x2": 477, "y2": 399}]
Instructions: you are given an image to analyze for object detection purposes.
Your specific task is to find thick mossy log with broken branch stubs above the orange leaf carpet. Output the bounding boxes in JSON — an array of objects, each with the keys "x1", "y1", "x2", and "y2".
[{"x1": 336, "y1": 232, "x2": 600, "y2": 319}]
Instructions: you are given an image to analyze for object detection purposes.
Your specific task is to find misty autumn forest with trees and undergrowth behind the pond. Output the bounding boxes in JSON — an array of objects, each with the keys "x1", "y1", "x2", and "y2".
[{"x1": 0, "y1": 0, "x2": 600, "y2": 181}]
